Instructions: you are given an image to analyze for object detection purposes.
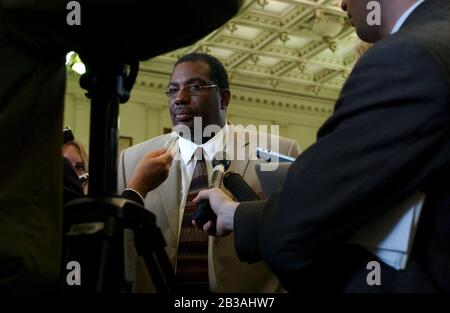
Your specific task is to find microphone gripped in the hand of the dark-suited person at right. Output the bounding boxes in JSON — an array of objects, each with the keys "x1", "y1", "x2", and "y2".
[{"x1": 193, "y1": 152, "x2": 231, "y2": 227}]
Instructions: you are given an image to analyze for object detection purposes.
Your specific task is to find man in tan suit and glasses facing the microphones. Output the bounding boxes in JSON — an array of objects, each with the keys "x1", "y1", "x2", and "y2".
[{"x1": 118, "y1": 54, "x2": 299, "y2": 292}]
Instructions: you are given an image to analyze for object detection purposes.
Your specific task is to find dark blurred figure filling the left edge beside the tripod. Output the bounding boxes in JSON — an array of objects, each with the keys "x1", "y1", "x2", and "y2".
[{"x1": 0, "y1": 14, "x2": 66, "y2": 293}]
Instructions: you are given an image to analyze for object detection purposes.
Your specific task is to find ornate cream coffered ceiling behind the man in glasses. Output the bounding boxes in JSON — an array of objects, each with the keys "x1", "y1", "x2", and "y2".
[{"x1": 141, "y1": 0, "x2": 359, "y2": 100}]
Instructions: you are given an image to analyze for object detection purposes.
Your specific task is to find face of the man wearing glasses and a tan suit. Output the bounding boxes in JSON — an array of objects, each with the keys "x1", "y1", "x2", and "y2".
[{"x1": 168, "y1": 61, "x2": 229, "y2": 130}]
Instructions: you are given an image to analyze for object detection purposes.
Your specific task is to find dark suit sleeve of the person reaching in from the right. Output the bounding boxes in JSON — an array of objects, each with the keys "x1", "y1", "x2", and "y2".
[{"x1": 255, "y1": 38, "x2": 450, "y2": 285}]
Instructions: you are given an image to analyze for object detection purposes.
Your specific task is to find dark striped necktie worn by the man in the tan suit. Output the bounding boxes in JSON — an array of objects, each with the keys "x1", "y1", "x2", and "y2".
[{"x1": 176, "y1": 148, "x2": 209, "y2": 293}]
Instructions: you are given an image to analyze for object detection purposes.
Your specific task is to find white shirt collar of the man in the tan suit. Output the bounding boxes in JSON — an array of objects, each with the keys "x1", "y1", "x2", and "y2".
[{"x1": 178, "y1": 123, "x2": 230, "y2": 165}]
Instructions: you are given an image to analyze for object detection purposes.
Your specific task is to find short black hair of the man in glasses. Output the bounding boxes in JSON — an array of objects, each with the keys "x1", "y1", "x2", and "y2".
[{"x1": 174, "y1": 52, "x2": 229, "y2": 89}]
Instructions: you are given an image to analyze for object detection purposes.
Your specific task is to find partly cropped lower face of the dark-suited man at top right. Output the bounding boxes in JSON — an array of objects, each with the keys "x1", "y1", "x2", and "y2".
[{"x1": 342, "y1": 0, "x2": 382, "y2": 43}]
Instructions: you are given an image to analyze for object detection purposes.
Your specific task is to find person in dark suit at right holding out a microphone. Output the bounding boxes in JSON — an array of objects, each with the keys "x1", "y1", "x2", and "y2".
[{"x1": 196, "y1": 0, "x2": 450, "y2": 292}]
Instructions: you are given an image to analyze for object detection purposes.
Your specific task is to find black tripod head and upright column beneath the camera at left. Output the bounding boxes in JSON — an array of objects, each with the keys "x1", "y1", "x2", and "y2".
[{"x1": 80, "y1": 57, "x2": 139, "y2": 196}]
